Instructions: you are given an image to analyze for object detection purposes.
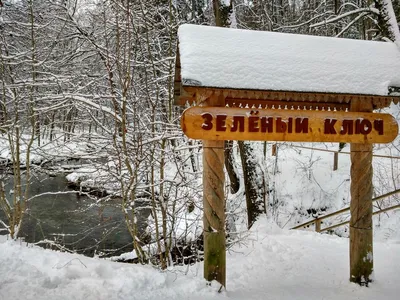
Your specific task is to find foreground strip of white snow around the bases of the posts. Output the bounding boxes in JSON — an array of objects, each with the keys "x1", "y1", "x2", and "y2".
[{"x1": 0, "y1": 218, "x2": 400, "y2": 300}]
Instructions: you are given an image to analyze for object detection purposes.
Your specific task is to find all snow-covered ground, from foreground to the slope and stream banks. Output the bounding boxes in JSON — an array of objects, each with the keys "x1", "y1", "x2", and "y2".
[{"x1": 0, "y1": 100, "x2": 400, "y2": 300}]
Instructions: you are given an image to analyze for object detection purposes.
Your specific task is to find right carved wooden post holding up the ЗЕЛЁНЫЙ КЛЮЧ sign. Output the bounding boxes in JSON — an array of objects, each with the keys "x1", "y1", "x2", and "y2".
[{"x1": 350, "y1": 100, "x2": 373, "y2": 285}]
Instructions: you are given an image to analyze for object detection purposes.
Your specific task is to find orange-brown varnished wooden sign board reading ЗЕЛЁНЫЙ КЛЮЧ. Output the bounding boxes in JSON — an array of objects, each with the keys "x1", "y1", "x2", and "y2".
[{"x1": 181, "y1": 106, "x2": 398, "y2": 143}]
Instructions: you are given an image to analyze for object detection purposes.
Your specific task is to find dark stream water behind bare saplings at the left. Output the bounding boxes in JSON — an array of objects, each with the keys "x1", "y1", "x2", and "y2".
[{"x1": 0, "y1": 175, "x2": 141, "y2": 256}]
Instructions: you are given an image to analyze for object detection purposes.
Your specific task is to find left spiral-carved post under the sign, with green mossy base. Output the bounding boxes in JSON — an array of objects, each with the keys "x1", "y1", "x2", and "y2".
[{"x1": 203, "y1": 95, "x2": 226, "y2": 287}]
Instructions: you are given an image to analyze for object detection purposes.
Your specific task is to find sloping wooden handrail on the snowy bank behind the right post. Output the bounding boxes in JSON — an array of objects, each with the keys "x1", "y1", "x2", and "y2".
[{"x1": 292, "y1": 189, "x2": 400, "y2": 232}]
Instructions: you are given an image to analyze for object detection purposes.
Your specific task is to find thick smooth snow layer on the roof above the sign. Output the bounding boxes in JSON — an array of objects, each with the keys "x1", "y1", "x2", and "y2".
[{"x1": 178, "y1": 24, "x2": 400, "y2": 96}]
